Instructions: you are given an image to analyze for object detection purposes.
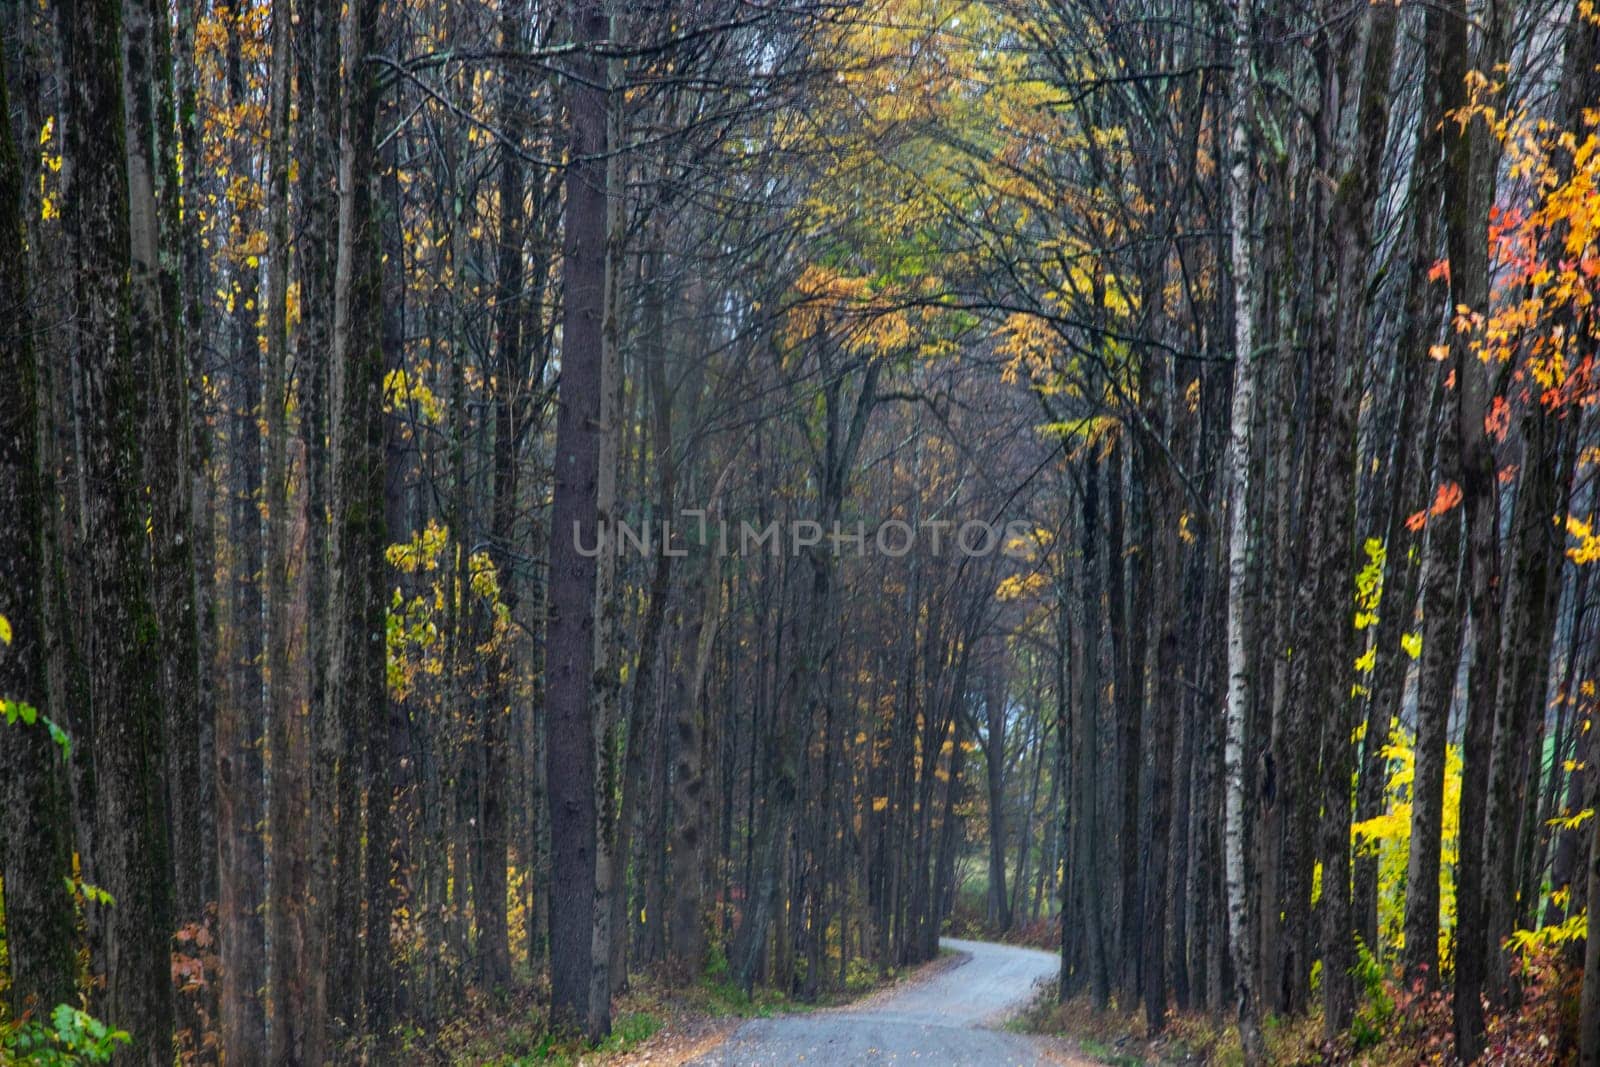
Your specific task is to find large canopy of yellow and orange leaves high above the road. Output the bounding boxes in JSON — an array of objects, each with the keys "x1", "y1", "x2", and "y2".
[{"x1": 784, "y1": 0, "x2": 1152, "y2": 367}]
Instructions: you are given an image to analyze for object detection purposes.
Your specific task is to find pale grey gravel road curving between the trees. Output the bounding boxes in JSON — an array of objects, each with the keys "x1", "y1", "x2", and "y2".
[{"x1": 694, "y1": 937, "x2": 1081, "y2": 1067}]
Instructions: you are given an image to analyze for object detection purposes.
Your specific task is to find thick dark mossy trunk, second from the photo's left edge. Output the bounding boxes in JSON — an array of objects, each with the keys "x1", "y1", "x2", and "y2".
[{"x1": 61, "y1": 0, "x2": 173, "y2": 1067}]
